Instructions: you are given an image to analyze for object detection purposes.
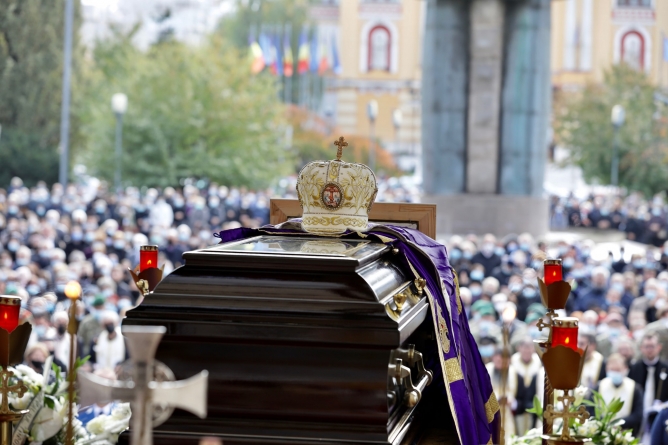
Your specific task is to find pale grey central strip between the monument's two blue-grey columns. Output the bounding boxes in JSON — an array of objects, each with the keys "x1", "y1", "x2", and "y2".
[{"x1": 466, "y1": 0, "x2": 505, "y2": 193}]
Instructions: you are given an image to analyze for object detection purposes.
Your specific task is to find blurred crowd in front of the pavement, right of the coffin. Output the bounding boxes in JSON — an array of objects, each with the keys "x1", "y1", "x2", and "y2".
[{"x1": 446, "y1": 234, "x2": 668, "y2": 444}]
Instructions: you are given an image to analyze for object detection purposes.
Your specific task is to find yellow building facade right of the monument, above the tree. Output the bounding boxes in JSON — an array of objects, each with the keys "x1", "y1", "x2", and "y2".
[{"x1": 551, "y1": 0, "x2": 668, "y2": 89}]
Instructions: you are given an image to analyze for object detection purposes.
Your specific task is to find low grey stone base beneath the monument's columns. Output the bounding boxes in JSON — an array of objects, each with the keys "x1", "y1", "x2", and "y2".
[{"x1": 422, "y1": 194, "x2": 549, "y2": 237}]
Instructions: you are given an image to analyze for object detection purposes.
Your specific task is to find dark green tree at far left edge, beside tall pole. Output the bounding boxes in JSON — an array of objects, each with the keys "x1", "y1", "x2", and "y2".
[{"x1": 0, "y1": 0, "x2": 80, "y2": 186}]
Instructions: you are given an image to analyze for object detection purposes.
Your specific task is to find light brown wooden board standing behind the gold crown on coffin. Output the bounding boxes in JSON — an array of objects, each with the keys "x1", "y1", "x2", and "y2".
[{"x1": 269, "y1": 199, "x2": 436, "y2": 239}]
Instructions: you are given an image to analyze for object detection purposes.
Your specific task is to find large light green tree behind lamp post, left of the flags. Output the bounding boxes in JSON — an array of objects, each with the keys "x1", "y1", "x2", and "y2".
[{"x1": 78, "y1": 35, "x2": 291, "y2": 187}]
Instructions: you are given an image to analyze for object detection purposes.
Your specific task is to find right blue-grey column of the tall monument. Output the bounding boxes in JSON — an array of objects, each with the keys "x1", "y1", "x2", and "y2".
[{"x1": 499, "y1": 0, "x2": 551, "y2": 197}]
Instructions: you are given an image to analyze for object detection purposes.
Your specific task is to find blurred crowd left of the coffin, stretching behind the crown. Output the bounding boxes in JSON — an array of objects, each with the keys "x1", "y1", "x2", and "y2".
[{"x1": 0, "y1": 176, "x2": 418, "y2": 375}]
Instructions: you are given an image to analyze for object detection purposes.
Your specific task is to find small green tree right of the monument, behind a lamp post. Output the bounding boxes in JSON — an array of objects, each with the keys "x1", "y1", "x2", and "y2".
[{"x1": 555, "y1": 65, "x2": 668, "y2": 195}]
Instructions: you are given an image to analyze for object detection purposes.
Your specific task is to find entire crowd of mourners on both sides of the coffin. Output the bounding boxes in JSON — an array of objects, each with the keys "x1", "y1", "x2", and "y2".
[{"x1": 0, "y1": 173, "x2": 668, "y2": 443}]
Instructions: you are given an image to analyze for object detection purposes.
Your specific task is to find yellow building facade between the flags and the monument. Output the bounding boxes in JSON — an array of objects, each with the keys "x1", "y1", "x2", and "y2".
[{"x1": 312, "y1": 0, "x2": 425, "y2": 169}]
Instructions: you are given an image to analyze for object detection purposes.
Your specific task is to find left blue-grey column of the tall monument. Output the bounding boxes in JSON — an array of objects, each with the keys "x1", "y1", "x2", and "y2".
[{"x1": 422, "y1": 0, "x2": 469, "y2": 195}]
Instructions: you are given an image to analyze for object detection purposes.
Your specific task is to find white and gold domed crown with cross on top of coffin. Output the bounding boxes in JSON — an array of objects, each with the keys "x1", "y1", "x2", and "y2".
[{"x1": 297, "y1": 136, "x2": 378, "y2": 235}]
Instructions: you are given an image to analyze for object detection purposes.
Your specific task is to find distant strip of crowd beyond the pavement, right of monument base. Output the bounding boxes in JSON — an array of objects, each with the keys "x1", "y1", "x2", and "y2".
[{"x1": 550, "y1": 192, "x2": 668, "y2": 246}]
